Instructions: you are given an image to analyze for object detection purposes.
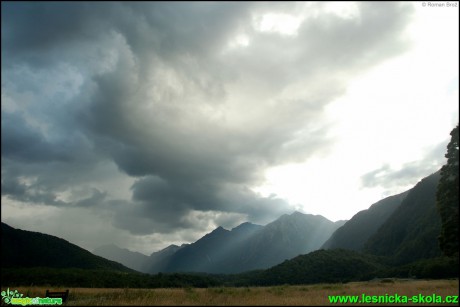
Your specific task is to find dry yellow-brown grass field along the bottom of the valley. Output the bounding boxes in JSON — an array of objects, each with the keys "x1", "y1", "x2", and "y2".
[{"x1": 2, "y1": 280, "x2": 459, "y2": 306}]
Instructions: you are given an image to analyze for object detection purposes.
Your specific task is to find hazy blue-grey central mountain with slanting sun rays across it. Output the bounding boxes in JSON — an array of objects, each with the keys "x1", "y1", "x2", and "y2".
[{"x1": 150, "y1": 212, "x2": 345, "y2": 273}]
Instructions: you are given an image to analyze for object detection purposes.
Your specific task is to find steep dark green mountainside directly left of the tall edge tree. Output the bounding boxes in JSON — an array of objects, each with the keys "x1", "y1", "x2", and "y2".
[{"x1": 364, "y1": 171, "x2": 441, "y2": 263}]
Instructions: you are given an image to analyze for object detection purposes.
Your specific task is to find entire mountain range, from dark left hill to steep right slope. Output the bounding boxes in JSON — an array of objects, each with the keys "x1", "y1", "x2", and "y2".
[{"x1": 1, "y1": 168, "x2": 452, "y2": 285}]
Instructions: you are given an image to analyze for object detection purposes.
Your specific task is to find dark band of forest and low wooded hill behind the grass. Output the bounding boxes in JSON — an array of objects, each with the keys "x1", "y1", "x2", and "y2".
[{"x1": 1, "y1": 249, "x2": 459, "y2": 288}]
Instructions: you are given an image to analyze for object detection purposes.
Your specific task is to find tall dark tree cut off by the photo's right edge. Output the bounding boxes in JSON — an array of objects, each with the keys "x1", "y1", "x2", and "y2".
[{"x1": 436, "y1": 124, "x2": 459, "y2": 256}]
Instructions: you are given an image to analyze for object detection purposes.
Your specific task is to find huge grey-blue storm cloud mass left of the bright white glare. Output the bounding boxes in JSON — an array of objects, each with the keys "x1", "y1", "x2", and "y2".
[{"x1": 2, "y1": 2, "x2": 411, "y2": 234}]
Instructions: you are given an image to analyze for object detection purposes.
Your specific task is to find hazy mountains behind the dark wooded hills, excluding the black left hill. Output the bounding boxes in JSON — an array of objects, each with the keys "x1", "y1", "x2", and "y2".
[{"x1": 95, "y1": 171, "x2": 441, "y2": 273}]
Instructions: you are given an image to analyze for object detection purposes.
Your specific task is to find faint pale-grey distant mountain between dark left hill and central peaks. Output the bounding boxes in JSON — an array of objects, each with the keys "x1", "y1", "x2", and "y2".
[{"x1": 93, "y1": 244, "x2": 150, "y2": 272}]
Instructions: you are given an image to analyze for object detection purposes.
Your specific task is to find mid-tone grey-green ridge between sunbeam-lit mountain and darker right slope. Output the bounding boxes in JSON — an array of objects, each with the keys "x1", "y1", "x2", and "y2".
[{"x1": 321, "y1": 191, "x2": 409, "y2": 251}]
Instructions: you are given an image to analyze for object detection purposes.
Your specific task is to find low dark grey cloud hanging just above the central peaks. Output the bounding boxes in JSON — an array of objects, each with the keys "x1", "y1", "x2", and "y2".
[{"x1": 117, "y1": 176, "x2": 292, "y2": 233}]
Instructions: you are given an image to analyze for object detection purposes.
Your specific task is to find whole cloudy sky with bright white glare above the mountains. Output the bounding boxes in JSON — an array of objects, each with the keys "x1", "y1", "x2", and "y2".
[{"x1": 1, "y1": 2, "x2": 459, "y2": 255}]
